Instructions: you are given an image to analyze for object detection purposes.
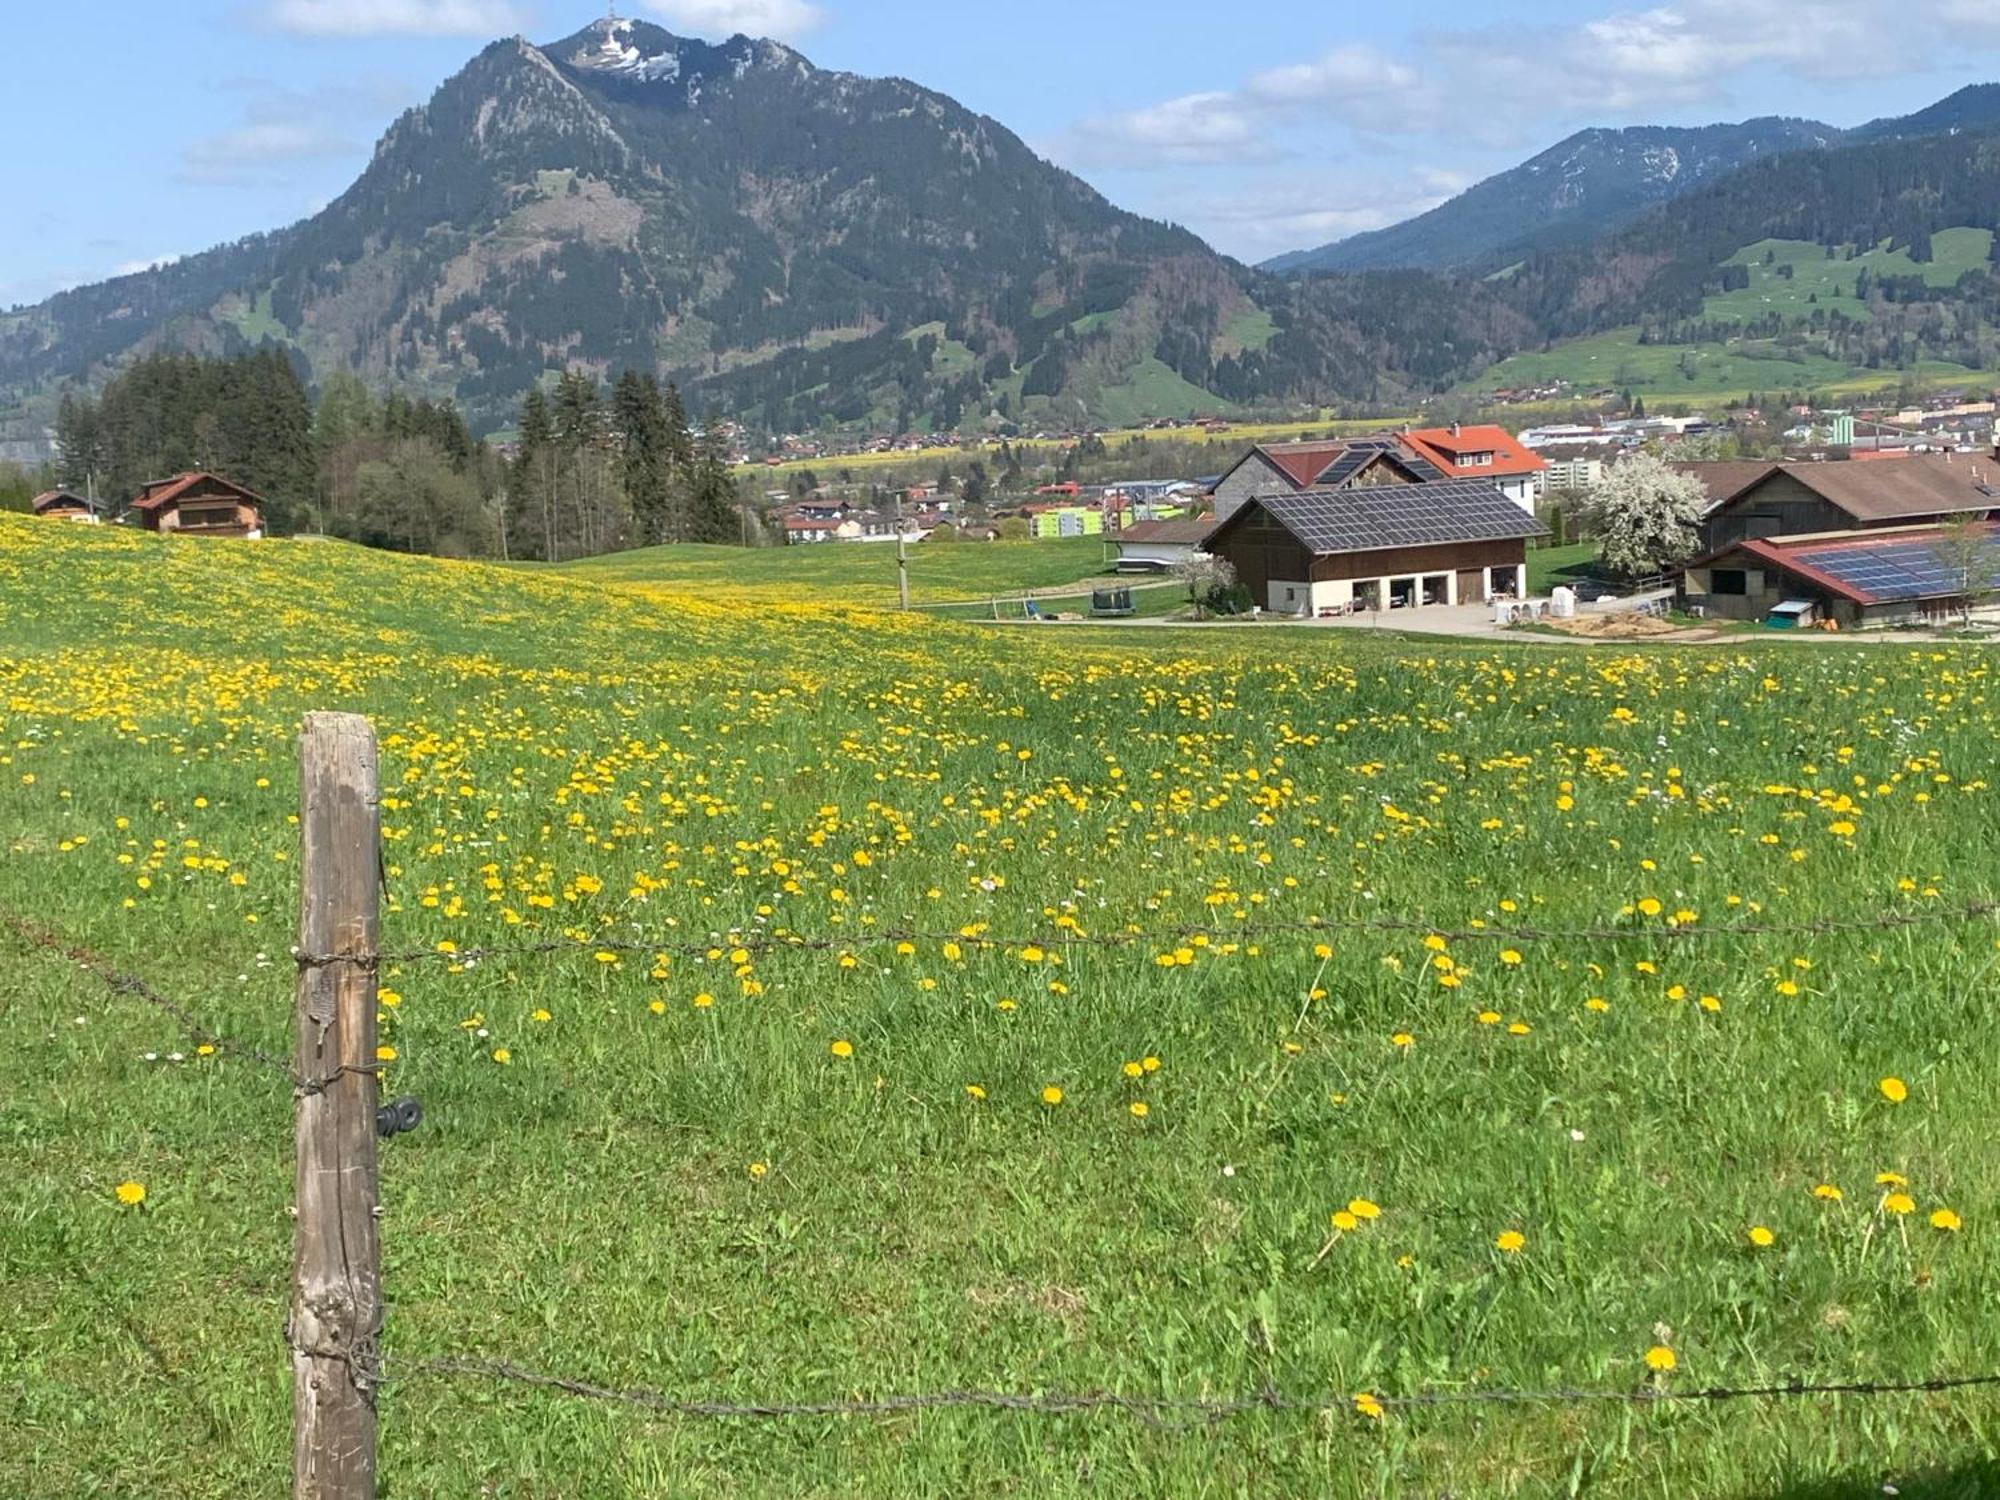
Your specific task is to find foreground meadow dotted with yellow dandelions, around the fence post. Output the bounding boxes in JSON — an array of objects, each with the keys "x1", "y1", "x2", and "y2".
[{"x1": 0, "y1": 518, "x2": 2000, "y2": 1500}]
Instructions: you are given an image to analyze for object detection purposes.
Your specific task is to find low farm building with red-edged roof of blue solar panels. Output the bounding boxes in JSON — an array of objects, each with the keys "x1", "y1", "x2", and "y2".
[{"x1": 1686, "y1": 522, "x2": 2000, "y2": 626}]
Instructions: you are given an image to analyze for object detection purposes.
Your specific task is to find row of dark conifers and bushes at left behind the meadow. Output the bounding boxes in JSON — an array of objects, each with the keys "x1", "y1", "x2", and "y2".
[{"x1": 43, "y1": 348, "x2": 760, "y2": 562}]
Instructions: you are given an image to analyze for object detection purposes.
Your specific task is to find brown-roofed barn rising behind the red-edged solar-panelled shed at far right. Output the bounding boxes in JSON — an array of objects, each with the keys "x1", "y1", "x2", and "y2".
[{"x1": 1702, "y1": 454, "x2": 2000, "y2": 552}]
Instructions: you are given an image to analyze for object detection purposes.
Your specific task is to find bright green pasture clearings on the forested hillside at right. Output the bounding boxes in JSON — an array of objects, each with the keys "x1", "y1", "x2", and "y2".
[{"x1": 1468, "y1": 228, "x2": 1992, "y2": 400}]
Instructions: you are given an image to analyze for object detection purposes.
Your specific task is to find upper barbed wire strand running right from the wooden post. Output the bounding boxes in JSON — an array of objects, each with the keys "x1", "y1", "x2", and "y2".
[{"x1": 292, "y1": 900, "x2": 2000, "y2": 968}]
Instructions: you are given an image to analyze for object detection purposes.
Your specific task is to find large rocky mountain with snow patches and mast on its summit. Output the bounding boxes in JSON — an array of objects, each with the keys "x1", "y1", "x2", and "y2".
[{"x1": 0, "y1": 22, "x2": 1526, "y2": 430}]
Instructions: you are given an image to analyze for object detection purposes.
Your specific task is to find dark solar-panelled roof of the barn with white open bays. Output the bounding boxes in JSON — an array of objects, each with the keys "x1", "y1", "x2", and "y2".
[{"x1": 1212, "y1": 478, "x2": 1548, "y2": 556}]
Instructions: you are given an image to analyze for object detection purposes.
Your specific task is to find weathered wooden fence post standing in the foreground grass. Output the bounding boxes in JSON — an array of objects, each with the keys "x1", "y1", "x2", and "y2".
[{"x1": 286, "y1": 714, "x2": 382, "y2": 1500}]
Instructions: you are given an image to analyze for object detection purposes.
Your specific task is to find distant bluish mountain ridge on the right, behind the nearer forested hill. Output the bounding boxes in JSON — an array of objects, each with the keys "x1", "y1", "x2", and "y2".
[{"x1": 1262, "y1": 84, "x2": 2000, "y2": 276}]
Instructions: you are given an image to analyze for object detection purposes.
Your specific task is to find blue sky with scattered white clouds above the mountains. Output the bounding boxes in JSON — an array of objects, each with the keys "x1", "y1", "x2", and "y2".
[{"x1": 0, "y1": 0, "x2": 2000, "y2": 308}]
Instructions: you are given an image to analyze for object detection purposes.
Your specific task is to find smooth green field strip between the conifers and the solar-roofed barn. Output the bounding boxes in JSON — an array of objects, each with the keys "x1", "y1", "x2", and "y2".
[{"x1": 538, "y1": 536, "x2": 1104, "y2": 606}]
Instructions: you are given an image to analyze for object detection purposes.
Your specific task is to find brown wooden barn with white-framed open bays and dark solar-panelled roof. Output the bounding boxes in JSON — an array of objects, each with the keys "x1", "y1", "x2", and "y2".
[{"x1": 1202, "y1": 480, "x2": 1546, "y2": 616}]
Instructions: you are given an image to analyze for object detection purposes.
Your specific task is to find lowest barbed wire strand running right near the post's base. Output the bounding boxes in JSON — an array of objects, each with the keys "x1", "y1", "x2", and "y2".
[{"x1": 390, "y1": 1358, "x2": 2000, "y2": 1426}]
